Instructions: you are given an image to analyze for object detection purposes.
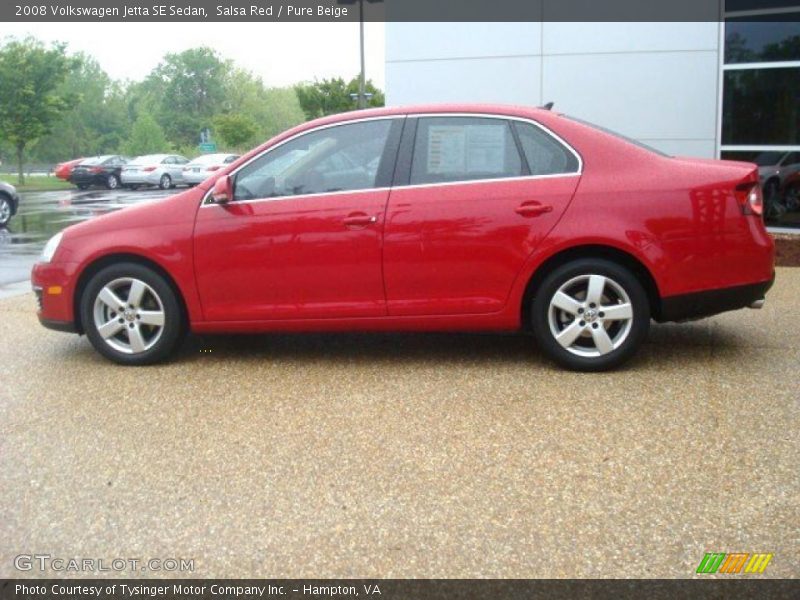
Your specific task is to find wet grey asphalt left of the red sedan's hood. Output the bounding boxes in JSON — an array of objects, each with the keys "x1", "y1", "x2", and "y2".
[{"x1": 0, "y1": 188, "x2": 177, "y2": 290}]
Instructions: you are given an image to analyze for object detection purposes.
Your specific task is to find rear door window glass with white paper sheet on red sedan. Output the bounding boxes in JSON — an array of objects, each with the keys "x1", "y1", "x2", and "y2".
[{"x1": 411, "y1": 117, "x2": 523, "y2": 184}]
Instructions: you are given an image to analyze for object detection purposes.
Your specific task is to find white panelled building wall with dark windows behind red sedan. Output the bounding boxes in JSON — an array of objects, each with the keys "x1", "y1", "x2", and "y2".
[{"x1": 386, "y1": 7, "x2": 800, "y2": 228}]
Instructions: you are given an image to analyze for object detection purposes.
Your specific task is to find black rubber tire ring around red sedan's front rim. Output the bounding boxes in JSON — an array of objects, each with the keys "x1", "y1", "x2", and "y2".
[{"x1": 80, "y1": 263, "x2": 186, "y2": 366}]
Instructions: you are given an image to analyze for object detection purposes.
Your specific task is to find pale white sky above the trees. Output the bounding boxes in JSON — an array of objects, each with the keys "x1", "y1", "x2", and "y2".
[{"x1": 0, "y1": 22, "x2": 385, "y2": 89}]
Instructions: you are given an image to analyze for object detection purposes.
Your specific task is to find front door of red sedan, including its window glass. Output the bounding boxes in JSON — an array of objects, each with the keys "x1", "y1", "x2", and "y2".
[{"x1": 194, "y1": 119, "x2": 402, "y2": 321}]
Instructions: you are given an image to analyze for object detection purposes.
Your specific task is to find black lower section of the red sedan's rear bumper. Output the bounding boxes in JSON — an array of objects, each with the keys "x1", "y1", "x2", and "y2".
[{"x1": 656, "y1": 273, "x2": 775, "y2": 322}]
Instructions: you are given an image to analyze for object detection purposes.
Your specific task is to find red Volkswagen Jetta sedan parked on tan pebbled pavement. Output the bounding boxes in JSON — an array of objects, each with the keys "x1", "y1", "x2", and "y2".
[{"x1": 32, "y1": 105, "x2": 774, "y2": 370}]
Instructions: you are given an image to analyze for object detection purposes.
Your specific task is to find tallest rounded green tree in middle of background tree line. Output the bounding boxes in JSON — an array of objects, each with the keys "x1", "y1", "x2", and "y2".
[{"x1": 148, "y1": 47, "x2": 231, "y2": 145}]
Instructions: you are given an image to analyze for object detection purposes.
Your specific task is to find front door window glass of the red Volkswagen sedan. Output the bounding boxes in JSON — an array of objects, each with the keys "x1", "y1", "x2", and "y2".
[{"x1": 234, "y1": 119, "x2": 392, "y2": 200}]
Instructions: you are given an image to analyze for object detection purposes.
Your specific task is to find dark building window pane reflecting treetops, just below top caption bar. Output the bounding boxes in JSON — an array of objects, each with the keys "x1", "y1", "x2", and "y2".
[{"x1": 725, "y1": 18, "x2": 800, "y2": 64}]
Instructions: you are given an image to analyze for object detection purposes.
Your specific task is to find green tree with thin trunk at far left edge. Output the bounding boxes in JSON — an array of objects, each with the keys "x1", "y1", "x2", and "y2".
[{"x1": 0, "y1": 38, "x2": 77, "y2": 185}]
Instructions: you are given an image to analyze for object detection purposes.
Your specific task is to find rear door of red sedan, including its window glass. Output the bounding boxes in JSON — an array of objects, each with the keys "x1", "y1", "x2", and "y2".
[{"x1": 384, "y1": 115, "x2": 581, "y2": 315}]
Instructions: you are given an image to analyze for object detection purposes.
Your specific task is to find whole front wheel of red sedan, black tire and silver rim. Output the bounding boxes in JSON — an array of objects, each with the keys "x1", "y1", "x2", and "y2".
[{"x1": 80, "y1": 263, "x2": 186, "y2": 366}]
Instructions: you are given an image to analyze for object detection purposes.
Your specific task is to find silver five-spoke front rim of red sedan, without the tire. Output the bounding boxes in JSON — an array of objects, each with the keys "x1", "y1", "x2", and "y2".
[{"x1": 93, "y1": 277, "x2": 165, "y2": 354}]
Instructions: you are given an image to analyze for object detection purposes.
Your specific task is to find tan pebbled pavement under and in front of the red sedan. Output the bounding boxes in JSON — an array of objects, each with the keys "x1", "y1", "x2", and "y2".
[{"x1": 0, "y1": 268, "x2": 800, "y2": 578}]
